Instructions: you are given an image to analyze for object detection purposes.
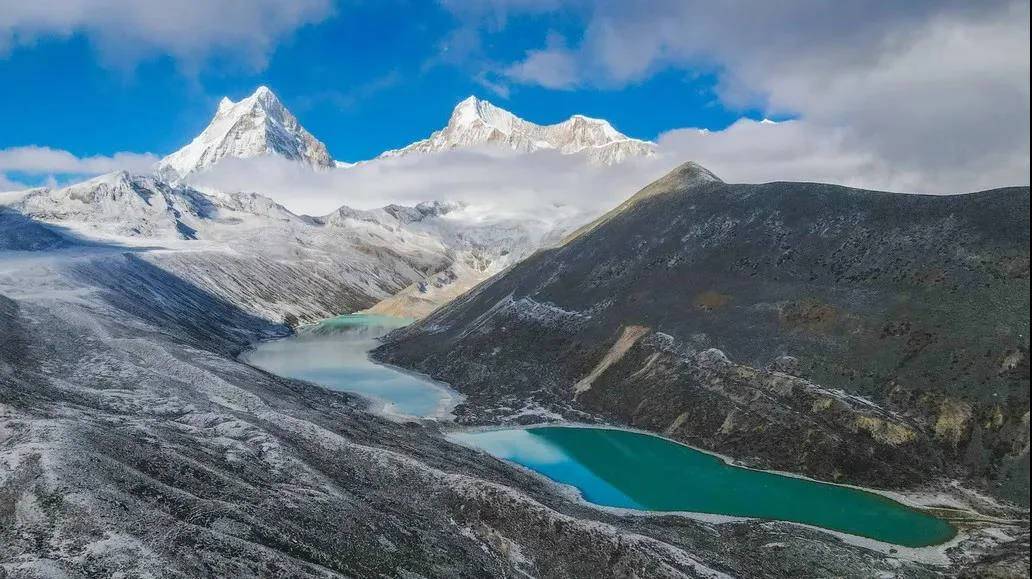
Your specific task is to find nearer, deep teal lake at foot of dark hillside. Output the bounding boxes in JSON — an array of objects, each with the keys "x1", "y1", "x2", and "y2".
[{"x1": 449, "y1": 426, "x2": 956, "y2": 547}]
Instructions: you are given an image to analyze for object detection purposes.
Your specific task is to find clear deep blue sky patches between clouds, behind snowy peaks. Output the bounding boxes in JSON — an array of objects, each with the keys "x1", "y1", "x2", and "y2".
[{"x1": 0, "y1": 2, "x2": 755, "y2": 160}]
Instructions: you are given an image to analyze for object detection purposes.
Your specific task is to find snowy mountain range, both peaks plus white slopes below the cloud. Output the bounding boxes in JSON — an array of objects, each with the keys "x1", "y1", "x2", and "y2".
[{"x1": 7, "y1": 87, "x2": 653, "y2": 320}]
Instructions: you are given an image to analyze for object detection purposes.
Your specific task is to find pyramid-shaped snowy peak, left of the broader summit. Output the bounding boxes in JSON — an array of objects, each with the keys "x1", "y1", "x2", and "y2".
[{"x1": 158, "y1": 87, "x2": 335, "y2": 181}]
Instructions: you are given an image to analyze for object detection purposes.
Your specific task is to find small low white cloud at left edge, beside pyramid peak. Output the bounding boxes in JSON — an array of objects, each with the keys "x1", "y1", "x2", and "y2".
[{"x1": 0, "y1": 147, "x2": 158, "y2": 183}]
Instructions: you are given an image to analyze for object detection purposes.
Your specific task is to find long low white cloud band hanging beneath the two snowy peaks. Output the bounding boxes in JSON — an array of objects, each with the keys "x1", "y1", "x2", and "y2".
[{"x1": 191, "y1": 150, "x2": 670, "y2": 219}]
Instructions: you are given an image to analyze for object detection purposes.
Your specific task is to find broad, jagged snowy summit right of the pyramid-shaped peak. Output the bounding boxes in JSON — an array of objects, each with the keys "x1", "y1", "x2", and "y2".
[{"x1": 379, "y1": 96, "x2": 655, "y2": 165}]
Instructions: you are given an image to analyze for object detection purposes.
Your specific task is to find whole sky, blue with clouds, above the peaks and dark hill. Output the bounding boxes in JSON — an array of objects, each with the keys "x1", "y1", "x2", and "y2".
[{"x1": 0, "y1": 0, "x2": 1030, "y2": 192}]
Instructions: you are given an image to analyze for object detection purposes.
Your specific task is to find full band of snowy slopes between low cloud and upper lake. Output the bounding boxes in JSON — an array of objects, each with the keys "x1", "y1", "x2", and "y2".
[{"x1": 7, "y1": 171, "x2": 580, "y2": 323}]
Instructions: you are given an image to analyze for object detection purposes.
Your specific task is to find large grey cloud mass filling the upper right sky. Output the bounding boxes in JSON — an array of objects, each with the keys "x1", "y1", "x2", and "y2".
[{"x1": 447, "y1": 0, "x2": 1030, "y2": 191}]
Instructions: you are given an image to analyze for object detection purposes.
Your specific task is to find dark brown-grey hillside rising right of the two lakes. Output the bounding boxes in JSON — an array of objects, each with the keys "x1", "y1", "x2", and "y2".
[{"x1": 376, "y1": 165, "x2": 1029, "y2": 504}]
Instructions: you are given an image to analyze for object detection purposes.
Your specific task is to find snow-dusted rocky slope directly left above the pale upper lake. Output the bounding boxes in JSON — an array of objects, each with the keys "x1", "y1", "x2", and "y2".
[{"x1": 8, "y1": 172, "x2": 456, "y2": 324}]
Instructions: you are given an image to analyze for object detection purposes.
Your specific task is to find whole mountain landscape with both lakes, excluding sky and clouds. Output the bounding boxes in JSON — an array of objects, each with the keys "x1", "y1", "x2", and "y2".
[{"x1": 0, "y1": 88, "x2": 1029, "y2": 579}]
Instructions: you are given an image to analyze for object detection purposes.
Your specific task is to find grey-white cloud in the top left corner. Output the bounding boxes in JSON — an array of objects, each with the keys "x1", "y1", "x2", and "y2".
[{"x1": 0, "y1": 0, "x2": 333, "y2": 66}]
